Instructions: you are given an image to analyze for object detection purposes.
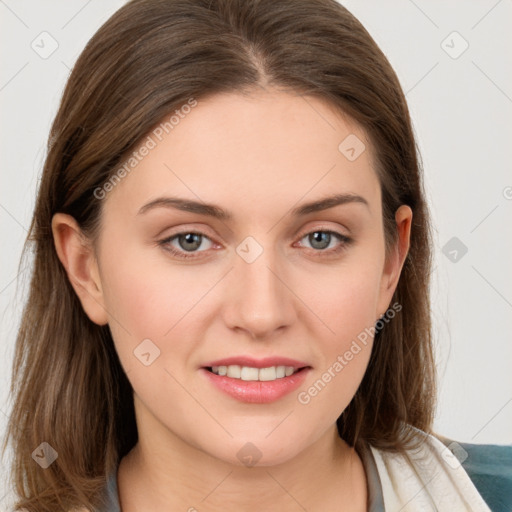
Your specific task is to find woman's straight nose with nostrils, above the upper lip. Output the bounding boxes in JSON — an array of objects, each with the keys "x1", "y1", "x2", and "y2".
[{"x1": 223, "y1": 244, "x2": 297, "y2": 340}]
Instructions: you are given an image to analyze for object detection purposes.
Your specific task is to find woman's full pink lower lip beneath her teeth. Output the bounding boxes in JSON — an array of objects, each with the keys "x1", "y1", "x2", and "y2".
[{"x1": 201, "y1": 368, "x2": 311, "y2": 404}]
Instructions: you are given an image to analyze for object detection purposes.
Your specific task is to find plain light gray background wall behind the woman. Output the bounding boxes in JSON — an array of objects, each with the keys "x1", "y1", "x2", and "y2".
[{"x1": 0, "y1": 0, "x2": 512, "y2": 510}]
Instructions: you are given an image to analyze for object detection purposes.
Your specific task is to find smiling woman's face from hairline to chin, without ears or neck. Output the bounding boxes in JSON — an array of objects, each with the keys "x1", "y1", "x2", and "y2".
[{"x1": 89, "y1": 91, "x2": 408, "y2": 465}]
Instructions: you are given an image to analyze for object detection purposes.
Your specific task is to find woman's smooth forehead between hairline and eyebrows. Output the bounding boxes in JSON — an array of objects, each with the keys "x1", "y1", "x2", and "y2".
[{"x1": 102, "y1": 90, "x2": 380, "y2": 222}]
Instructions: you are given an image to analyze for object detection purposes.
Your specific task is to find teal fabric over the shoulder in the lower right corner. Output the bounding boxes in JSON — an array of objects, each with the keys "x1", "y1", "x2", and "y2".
[{"x1": 435, "y1": 434, "x2": 512, "y2": 512}]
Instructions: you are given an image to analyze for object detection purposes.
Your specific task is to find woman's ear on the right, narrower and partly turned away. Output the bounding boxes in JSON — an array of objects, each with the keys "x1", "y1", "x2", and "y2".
[{"x1": 376, "y1": 204, "x2": 412, "y2": 320}]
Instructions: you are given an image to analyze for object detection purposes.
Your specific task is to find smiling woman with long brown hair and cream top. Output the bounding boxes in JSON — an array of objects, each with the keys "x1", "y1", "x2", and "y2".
[{"x1": 3, "y1": 0, "x2": 512, "y2": 512}]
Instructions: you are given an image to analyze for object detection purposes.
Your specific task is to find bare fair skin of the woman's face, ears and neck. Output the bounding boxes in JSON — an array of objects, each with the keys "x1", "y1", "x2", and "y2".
[{"x1": 52, "y1": 90, "x2": 412, "y2": 512}]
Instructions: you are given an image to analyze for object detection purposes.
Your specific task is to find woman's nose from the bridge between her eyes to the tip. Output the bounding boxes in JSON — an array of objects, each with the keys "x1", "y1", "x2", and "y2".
[{"x1": 228, "y1": 237, "x2": 295, "y2": 337}]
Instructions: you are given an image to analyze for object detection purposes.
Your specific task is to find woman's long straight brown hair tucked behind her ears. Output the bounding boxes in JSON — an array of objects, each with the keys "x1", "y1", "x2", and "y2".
[{"x1": 4, "y1": 0, "x2": 435, "y2": 512}]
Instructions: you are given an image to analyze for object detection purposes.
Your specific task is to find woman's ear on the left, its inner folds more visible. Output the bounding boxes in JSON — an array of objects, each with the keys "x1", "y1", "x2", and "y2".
[{"x1": 52, "y1": 213, "x2": 108, "y2": 325}]
